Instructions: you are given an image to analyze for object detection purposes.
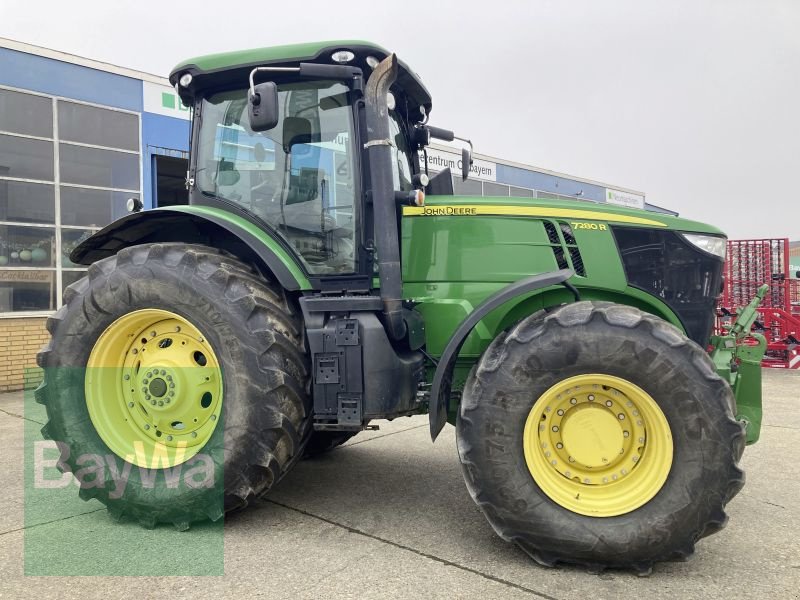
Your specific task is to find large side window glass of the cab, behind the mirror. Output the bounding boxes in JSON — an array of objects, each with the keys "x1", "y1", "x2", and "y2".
[{"x1": 195, "y1": 81, "x2": 357, "y2": 274}]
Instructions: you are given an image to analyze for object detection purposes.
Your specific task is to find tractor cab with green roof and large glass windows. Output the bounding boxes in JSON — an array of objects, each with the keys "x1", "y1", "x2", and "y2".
[{"x1": 170, "y1": 42, "x2": 462, "y2": 291}]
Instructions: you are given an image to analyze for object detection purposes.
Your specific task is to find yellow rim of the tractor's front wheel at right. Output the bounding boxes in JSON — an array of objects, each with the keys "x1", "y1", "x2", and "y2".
[{"x1": 523, "y1": 374, "x2": 672, "y2": 517}]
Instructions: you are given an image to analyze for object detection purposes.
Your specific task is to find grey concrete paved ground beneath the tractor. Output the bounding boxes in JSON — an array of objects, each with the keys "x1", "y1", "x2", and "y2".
[{"x1": 0, "y1": 370, "x2": 800, "y2": 600}]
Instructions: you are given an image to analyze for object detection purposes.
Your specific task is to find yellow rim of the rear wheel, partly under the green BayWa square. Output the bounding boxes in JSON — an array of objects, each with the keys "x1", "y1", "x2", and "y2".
[{"x1": 85, "y1": 309, "x2": 222, "y2": 468}]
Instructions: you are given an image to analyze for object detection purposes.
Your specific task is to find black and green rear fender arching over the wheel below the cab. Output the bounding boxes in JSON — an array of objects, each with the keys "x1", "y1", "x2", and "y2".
[{"x1": 70, "y1": 206, "x2": 311, "y2": 291}]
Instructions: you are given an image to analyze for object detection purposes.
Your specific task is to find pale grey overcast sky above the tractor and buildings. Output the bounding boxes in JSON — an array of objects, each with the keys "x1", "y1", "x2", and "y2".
[{"x1": 0, "y1": 0, "x2": 800, "y2": 240}]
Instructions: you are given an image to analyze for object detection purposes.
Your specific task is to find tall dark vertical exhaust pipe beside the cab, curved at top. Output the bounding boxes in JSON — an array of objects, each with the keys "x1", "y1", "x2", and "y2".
[{"x1": 364, "y1": 54, "x2": 406, "y2": 340}]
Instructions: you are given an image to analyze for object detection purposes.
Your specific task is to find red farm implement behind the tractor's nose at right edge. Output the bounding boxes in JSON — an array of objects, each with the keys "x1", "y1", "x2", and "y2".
[{"x1": 719, "y1": 238, "x2": 800, "y2": 369}]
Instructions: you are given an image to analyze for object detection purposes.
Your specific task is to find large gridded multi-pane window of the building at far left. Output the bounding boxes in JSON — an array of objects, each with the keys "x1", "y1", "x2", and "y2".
[{"x1": 0, "y1": 87, "x2": 141, "y2": 316}]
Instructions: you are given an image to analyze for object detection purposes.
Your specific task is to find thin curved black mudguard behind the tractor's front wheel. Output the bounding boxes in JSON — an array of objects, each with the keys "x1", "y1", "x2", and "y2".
[{"x1": 428, "y1": 269, "x2": 575, "y2": 441}]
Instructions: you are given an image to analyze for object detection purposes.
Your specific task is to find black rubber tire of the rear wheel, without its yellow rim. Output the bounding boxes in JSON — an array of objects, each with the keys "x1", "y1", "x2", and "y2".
[{"x1": 36, "y1": 243, "x2": 312, "y2": 529}]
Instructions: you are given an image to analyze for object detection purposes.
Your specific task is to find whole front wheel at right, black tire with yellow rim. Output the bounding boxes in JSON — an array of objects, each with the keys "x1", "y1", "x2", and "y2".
[{"x1": 457, "y1": 302, "x2": 744, "y2": 572}]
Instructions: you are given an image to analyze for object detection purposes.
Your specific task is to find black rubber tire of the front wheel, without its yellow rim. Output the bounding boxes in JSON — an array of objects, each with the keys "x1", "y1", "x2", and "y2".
[{"x1": 457, "y1": 301, "x2": 745, "y2": 574}]
